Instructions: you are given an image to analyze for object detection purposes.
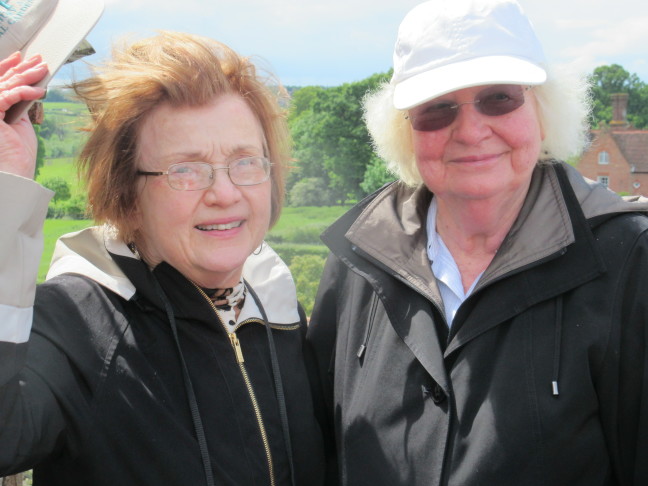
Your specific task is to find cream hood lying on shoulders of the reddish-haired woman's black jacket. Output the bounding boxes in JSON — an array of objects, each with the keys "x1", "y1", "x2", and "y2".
[{"x1": 46, "y1": 225, "x2": 300, "y2": 324}]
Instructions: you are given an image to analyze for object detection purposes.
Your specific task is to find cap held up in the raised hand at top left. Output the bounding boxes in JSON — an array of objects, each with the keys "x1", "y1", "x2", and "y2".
[{"x1": 0, "y1": 0, "x2": 104, "y2": 123}]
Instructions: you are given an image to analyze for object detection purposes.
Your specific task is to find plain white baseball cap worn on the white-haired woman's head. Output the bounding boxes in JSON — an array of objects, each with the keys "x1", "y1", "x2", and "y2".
[{"x1": 391, "y1": 0, "x2": 547, "y2": 110}]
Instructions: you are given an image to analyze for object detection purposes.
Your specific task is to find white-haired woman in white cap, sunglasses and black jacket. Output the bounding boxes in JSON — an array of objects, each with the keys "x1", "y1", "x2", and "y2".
[{"x1": 308, "y1": 0, "x2": 648, "y2": 486}]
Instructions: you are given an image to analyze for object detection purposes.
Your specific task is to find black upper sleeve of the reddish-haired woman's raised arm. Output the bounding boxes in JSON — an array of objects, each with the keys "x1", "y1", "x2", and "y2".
[{"x1": 0, "y1": 275, "x2": 128, "y2": 476}]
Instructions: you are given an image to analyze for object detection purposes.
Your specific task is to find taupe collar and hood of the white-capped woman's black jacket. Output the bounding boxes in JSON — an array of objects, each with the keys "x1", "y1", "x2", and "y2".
[{"x1": 322, "y1": 162, "x2": 648, "y2": 304}]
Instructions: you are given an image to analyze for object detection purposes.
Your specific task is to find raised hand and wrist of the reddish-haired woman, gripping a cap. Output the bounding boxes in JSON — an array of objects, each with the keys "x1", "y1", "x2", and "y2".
[{"x1": 0, "y1": 52, "x2": 47, "y2": 178}]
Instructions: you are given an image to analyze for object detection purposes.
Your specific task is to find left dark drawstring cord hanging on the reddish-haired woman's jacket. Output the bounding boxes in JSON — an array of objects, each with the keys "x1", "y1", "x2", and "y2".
[{"x1": 151, "y1": 272, "x2": 215, "y2": 486}]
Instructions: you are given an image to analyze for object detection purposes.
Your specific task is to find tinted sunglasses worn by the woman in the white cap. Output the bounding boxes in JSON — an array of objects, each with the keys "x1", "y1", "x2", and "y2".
[{"x1": 407, "y1": 84, "x2": 529, "y2": 132}]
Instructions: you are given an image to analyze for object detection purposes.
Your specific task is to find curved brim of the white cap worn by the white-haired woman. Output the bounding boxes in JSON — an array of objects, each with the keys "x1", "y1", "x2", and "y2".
[{"x1": 393, "y1": 56, "x2": 547, "y2": 110}]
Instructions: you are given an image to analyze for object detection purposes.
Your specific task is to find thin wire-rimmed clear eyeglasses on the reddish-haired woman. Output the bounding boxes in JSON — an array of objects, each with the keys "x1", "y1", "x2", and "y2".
[{"x1": 137, "y1": 157, "x2": 273, "y2": 191}]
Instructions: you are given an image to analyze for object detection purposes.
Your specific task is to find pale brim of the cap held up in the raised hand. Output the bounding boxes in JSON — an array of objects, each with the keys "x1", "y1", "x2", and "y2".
[{"x1": 5, "y1": 0, "x2": 104, "y2": 123}]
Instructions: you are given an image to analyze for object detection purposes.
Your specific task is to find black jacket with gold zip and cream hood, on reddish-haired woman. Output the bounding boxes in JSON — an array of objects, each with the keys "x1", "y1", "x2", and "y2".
[{"x1": 0, "y1": 221, "x2": 323, "y2": 486}]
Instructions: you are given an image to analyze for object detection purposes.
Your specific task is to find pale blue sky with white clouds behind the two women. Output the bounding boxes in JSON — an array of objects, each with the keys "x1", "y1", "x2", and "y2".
[{"x1": 59, "y1": 0, "x2": 648, "y2": 86}]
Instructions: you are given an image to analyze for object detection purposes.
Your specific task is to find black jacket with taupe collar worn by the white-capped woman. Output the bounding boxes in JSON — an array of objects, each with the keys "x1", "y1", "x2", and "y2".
[{"x1": 308, "y1": 161, "x2": 648, "y2": 486}]
